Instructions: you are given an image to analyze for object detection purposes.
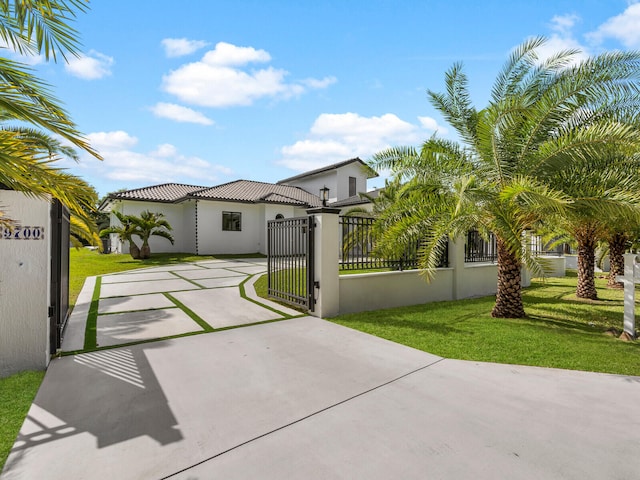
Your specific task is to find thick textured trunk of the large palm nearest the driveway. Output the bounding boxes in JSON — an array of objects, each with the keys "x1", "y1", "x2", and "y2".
[{"x1": 491, "y1": 237, "x2": 525, "y2": 318}]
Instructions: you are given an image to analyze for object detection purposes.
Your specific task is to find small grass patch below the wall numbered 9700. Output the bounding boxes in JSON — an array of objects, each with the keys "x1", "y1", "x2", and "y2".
[{"x1": 0, "y1": 372, "x2": 44, "y2": 471}]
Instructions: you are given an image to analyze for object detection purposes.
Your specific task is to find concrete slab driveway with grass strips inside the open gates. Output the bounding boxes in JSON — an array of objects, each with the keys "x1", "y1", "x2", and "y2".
[{"x1": 62, "y1": 258, "x2": 301, "y2": 352}]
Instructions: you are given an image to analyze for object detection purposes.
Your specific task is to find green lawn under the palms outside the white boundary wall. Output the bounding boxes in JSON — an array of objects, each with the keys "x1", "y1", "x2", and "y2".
[{"x1": 331, "y1": 272, "x2": 640, "y2": 375}]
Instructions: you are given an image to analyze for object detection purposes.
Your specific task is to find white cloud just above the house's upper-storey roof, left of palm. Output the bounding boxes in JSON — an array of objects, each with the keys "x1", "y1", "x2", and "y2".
[{"x1": 278, "y1": 113, "x2": 438, "y2": 171}]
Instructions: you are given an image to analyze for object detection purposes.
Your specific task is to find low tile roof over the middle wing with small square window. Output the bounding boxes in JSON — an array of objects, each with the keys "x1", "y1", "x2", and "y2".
[{"x1": 188, "y1": 180, "x2": 322, "y2": 207}]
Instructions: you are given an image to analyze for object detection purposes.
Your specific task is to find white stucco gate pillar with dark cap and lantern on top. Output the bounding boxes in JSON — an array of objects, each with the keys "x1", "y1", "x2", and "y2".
[{"x1": 307, "y1": 207, "x2": 340, "y2": 318}]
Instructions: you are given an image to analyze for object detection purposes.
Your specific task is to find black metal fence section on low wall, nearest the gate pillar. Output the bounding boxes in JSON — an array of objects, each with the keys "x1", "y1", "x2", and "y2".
[{"x1": 339, "y1": 216, "x2": 449, "y2": 270}]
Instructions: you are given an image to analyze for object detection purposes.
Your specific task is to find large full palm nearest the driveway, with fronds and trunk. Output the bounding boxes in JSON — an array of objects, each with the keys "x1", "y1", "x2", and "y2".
[{"x1": 372, "y1": 38, "x2": 640, "y2": 318}]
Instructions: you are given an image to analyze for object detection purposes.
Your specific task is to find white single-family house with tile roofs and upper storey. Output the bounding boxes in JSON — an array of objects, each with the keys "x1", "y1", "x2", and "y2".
[{"x1": 99, "y1": 158, "x2": 377, "y2": 255}]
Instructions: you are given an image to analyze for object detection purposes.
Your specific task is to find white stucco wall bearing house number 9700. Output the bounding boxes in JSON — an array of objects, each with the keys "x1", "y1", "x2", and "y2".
[{"x1": 0, "y1": 190, "x2": 51, "y2": 377}]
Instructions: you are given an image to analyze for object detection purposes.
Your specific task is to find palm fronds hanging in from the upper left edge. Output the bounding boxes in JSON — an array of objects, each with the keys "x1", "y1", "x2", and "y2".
[{"x1": 0, "y1": 0, "x2": 100, "y2": 231}]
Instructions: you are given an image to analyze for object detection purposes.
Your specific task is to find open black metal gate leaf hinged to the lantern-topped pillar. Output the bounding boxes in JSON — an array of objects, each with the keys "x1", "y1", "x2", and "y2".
[{"x1": 267, "y1": 216, "x2": 315, "y2": 312}]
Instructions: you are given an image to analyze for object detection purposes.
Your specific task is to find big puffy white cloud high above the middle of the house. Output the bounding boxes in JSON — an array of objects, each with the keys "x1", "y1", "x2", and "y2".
[{"x1": 162, "y1": 42, "x2": 336, "y2": 107}]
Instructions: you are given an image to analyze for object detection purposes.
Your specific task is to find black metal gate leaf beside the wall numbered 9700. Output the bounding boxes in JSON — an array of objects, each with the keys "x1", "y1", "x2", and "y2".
[{"x1": 49, "y1": 200, "x2": 70, "y2": 354}]
